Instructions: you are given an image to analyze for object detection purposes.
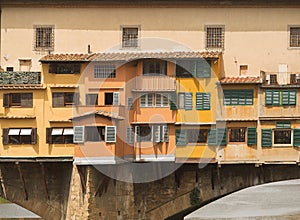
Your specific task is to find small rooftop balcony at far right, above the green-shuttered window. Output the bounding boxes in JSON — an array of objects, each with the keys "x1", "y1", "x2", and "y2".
[{"x1": 260, "y1": 71, "x2": 300, "y2": 87}]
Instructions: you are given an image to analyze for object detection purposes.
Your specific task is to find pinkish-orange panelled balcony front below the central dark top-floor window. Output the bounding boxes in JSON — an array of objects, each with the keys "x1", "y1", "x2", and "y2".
[{"x1": 133, "y1": 76, "x2": 176, "y2": 92}]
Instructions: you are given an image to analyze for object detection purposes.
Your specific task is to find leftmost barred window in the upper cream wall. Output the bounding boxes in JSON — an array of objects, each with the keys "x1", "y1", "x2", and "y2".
[{"x1": 34, "y1": 25, "x2": 54, "y2": 51}]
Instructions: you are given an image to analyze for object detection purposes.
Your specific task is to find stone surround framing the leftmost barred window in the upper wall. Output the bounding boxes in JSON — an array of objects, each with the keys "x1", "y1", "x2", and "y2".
[{"x1": 33, "y1": 25, "x2": 55, "y2": 52}]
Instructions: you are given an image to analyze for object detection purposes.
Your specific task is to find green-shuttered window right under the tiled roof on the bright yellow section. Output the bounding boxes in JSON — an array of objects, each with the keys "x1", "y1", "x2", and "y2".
[{"x1": 176, "y1": 59, "x2": 211, "y2": 78}]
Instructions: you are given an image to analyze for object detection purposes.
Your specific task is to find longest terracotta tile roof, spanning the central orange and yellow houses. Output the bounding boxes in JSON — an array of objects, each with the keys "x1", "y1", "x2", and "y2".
[{"x1": 40, "y1": 51, "x2": 221, "y2": 62}]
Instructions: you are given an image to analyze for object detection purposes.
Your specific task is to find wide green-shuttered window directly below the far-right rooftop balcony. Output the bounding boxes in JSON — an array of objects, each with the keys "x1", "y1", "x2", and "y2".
[{"x1": 265, "y1": 90, "x2": 297, "y2": 106}]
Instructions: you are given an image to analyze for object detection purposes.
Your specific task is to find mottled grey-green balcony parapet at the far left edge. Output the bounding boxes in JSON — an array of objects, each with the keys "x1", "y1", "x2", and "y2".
[{"x1": 0, "y1": 71, "x2": 41, "y2": 85}]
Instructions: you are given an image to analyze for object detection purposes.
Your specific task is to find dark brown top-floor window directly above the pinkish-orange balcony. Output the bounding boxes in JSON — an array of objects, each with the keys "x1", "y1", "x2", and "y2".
[{"x1": 143, "y1": 60, "x2": 167, "y2": 75}]
